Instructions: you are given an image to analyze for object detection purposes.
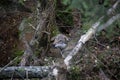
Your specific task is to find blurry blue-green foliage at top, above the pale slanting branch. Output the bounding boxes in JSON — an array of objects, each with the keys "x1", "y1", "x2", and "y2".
[{"x1": 62, "y1": 0, "x2": 106, "y2": 22}]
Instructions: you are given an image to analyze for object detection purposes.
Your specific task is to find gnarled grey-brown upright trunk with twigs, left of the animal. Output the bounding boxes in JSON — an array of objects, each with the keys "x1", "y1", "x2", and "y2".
[{"x1": 20, "y1": 2, "x2": 50, "y2": 66}]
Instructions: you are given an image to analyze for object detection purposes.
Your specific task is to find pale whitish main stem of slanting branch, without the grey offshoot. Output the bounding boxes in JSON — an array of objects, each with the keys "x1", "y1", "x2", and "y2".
[{"x1": 64, "y1": 21, "x2": 100, "y2": 68}]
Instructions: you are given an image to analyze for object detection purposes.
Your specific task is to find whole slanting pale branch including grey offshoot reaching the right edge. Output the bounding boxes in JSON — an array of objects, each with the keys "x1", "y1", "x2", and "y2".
[{"x1": 64, "y1": 14, "x2": 120, "y2": 68}]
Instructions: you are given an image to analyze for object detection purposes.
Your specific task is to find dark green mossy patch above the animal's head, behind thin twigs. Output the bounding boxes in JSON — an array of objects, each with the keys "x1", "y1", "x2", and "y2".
[{"x1": 56, "y1": 0, "x2": 73, "y2": 26}]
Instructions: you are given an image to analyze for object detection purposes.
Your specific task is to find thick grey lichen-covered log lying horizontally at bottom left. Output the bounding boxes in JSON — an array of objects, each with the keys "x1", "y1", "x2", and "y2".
[{"x1": 0, "y1": 66, "x2": 52, "y2": 79}]
